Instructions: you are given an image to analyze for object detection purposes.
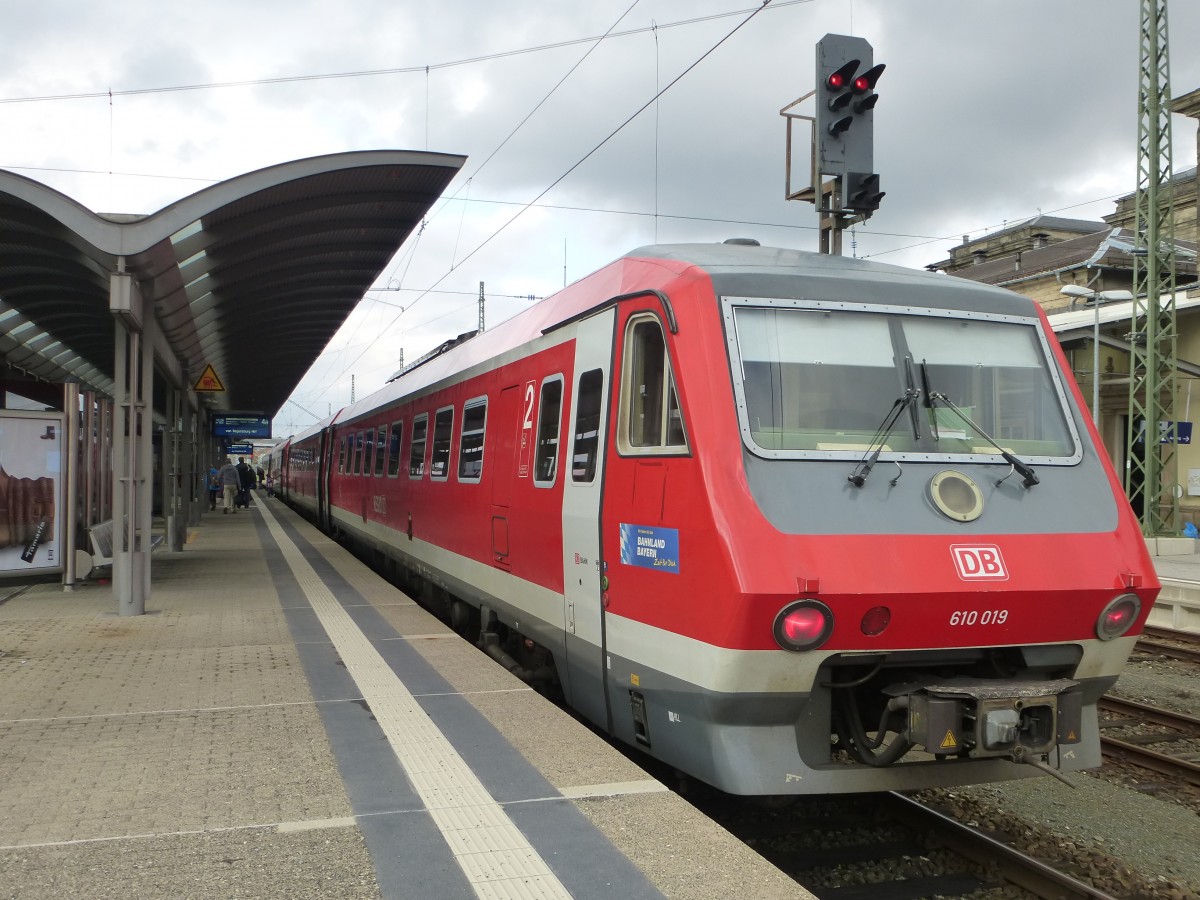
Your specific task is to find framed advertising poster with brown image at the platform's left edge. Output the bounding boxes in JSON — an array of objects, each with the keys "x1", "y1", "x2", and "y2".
[{"x1": 0, "y1": 409, "x2": 64, "y2": 577}]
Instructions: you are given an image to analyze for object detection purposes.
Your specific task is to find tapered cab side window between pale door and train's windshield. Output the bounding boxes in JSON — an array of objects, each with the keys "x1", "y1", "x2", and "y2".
[{"x1": 620, "y1": 316, "x2": 688, "y2": 452}]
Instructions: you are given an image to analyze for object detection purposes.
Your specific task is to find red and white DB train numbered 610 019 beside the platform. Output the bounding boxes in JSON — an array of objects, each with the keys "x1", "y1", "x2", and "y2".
[{"x1": 271, "y1": 240, "x2": 1158, "y2": 794}]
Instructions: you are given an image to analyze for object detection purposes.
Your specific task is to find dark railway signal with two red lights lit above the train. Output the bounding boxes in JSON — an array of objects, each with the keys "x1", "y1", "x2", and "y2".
[{"x1": 779, "y1": 35, "x2": 884, "y2": 256}]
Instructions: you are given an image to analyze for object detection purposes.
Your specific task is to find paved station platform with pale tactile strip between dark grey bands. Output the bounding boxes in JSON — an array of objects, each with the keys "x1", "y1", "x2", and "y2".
[{"x1": 0, "y1": 493, "x2": 810, "y2": 900}]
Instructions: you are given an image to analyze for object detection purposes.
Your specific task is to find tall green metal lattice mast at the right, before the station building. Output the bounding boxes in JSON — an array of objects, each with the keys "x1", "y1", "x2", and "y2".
[{"x1": 1126, "y1": 0, "x2": 1180, "y2": 535}]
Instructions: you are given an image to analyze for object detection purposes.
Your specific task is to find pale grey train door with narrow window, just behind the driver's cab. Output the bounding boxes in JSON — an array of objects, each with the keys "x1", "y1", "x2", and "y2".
[{"x1": 563, "y1": 307, "x2": 617, "y2": 726}]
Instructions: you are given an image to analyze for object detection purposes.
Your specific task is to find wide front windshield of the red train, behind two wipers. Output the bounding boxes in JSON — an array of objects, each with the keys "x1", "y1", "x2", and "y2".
[{"x1": 726, "y1": 300, "x2": 1079, "y2": 462}]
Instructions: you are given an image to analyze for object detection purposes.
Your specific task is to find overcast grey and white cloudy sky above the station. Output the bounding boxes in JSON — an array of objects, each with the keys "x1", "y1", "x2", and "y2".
[{"x1": 0, "y1": 0, "x2": 1200, "y2": 436}]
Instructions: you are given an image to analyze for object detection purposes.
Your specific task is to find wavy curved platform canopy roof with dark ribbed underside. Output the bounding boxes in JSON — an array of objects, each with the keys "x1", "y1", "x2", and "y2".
[{"x1": 0, "y1": 150, "x2": 466, "y2": 416}]
